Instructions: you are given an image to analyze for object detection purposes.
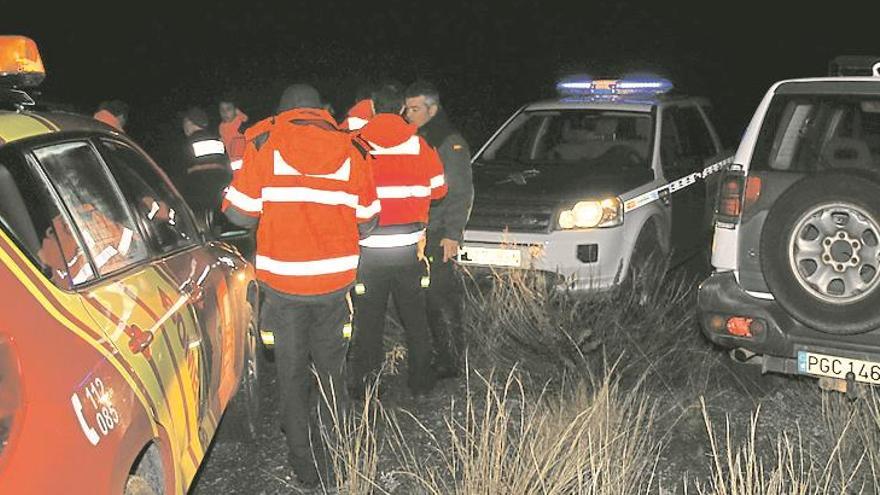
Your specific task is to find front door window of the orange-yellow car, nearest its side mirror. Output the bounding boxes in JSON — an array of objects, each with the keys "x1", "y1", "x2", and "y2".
[{"x1": 100, "y1": 140, "x2": 198, "y2": 253}]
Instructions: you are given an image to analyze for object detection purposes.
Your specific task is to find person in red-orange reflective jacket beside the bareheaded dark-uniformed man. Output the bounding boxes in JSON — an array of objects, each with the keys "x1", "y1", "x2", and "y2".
[{"x1": 353, "y1": 86, "x2": 446, "y2": 395}]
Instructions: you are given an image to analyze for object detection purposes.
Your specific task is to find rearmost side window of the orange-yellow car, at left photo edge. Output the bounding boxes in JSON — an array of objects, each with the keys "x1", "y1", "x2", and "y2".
[{"x1": 0, "y1": 148, "x2": 87, "y2": 289}]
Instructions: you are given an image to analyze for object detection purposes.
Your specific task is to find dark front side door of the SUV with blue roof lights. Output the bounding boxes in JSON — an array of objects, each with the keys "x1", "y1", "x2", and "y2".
[{"x1": 660, "y1": 103, "x2": 717, "y2": 260}]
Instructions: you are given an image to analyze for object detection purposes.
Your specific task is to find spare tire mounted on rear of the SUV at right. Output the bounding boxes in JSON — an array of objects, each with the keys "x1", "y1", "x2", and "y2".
[{"x1": 760, "y1": 173, "x2": 880, "y2": 335}]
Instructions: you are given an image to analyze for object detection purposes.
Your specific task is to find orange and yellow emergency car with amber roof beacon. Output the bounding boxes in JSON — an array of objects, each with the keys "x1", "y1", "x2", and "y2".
[{"x1": 0, "y1": 36, "x2": 259, "y2": 494}]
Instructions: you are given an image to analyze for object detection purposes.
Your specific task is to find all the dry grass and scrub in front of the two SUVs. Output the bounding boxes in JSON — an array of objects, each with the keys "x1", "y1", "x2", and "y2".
[{"x1": 308, "y1": 262, "x2": 880, "y2": 495}]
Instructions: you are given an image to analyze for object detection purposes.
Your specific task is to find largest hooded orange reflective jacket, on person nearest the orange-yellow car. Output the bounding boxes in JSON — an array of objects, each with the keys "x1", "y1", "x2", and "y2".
[{"x1": 223, "y1": 109, "x2": 380, "y2": 296}]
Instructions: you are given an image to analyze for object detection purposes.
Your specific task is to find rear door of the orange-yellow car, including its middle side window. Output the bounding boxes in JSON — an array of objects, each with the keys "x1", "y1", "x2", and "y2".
[{"x1": 31, "y1": 139, "x2": 207, "y2": 479}]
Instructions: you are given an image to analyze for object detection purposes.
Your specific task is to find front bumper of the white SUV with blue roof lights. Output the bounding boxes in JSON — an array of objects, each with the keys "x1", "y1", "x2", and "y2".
[{"x1": 460, "y1": 227, "x2": 632, "y2": 291}]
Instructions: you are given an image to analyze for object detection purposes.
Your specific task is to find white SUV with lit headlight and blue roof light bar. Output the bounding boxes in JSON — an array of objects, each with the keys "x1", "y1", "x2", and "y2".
[{"x1": 459, "y1": 77, "x2": 725, "y2": 290}]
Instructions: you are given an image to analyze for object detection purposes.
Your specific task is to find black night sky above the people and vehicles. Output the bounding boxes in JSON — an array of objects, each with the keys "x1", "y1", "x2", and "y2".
[{"x1": 0, "y1": 0, "x2": 880, "y2": 165}]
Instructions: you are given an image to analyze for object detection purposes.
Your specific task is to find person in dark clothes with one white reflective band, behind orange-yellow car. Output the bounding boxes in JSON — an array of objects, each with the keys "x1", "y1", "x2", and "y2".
[{"x1": 179, "y1": 107, "x2": 232, "y2": 229}]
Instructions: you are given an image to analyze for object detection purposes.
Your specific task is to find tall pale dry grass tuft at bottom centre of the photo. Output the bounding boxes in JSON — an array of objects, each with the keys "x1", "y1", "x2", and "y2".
[{"x1": 384, "y1": 371, "x2": 658, "y2": 495}]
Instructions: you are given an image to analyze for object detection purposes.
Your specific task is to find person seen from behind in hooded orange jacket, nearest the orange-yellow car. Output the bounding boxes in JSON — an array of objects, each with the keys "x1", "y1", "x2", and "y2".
[{"x1": 223, "y1": 84, "x2": 380, "y2": 487}]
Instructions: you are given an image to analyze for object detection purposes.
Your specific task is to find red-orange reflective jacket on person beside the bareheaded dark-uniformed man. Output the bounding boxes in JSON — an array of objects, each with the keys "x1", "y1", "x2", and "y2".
[{"x1": 359, "y1": 113, "x2": 446, "y2": 248}]
